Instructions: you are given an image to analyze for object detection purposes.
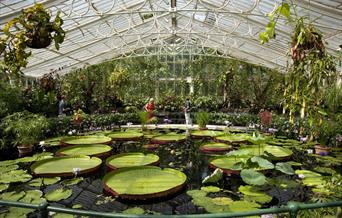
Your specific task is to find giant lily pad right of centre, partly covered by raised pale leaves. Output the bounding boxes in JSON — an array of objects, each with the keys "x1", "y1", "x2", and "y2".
[{"x1": 209, "y1": 156, "x2": 248, "y2": 174}]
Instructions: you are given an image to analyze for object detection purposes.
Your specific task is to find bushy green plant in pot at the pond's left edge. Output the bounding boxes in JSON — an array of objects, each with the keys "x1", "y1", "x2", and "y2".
[{"x1": 1, "y1": 112, "x2": 48, "y2": 156}]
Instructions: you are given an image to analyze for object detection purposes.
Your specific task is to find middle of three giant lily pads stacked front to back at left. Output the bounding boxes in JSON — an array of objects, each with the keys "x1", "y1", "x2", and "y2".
[{"x1": 56, "y1": 144, "x2": 112, "y2": 157}]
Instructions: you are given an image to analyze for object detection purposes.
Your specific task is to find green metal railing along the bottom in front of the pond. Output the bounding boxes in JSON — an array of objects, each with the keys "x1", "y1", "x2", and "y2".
[{"x1": 0, "y1": 200, "x2": 342, "y2": 218}]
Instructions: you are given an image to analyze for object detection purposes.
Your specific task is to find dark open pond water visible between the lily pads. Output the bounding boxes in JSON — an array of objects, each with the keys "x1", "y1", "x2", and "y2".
[{"x1": 0, "y1": 130, "x2": 320, "y2": 214}]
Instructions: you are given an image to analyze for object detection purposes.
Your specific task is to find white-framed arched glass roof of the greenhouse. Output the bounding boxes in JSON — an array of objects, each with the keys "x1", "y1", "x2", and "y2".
[{"x1": 0, "y1": 0, "x2": 342, "y2": 77}]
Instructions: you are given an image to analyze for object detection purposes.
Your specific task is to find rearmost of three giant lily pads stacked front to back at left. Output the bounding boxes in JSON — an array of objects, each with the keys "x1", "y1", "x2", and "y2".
[{"x1": 61, "y1": 135, "x2": 112, "y2": 146}]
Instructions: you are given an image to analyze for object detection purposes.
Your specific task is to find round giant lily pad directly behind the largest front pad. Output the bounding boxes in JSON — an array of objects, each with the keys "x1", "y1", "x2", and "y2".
[{"x1": 106, "y1": 153, "x2": 159, "y2": 170}]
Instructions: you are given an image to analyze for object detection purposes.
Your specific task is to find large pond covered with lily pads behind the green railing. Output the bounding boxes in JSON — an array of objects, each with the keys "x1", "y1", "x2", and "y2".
[{"x1": 0, "y1": 127, "x2": 342, "y2": 217}]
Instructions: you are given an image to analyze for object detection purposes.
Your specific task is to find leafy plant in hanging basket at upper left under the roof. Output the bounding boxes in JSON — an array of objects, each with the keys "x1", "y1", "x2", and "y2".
[{"x1": 0, "y1": 4, "x2": 65, "y2": 73}]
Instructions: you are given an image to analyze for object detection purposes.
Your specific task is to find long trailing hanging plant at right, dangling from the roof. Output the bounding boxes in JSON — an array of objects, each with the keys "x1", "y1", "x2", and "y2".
[{"x1": 259, "y1": 3, "x2": 337, "y2": 139}]
